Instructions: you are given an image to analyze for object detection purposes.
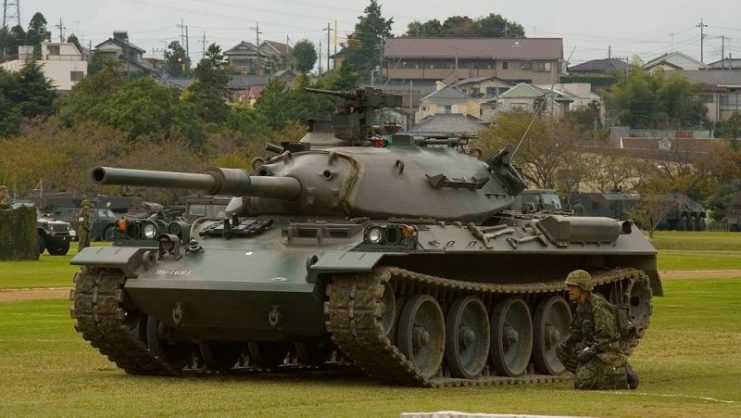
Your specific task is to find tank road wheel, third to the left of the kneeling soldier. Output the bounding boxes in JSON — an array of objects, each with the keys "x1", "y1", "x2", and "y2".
[{"x1": 445, "y1": 296, "x2": 491, "y2": 379}]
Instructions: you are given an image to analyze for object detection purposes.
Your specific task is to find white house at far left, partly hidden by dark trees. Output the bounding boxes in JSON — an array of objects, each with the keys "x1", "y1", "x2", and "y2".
[{"x1": 0, "y1": 42, "x2": 87, "y2": 92}]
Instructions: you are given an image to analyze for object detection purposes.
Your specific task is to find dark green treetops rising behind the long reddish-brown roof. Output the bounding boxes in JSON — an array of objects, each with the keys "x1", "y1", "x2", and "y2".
[{"x1": 404, "y1": 13, "x2": 525, "y2": 38}]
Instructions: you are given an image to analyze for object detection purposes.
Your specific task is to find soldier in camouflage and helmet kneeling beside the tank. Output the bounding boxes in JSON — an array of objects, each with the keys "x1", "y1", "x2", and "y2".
[{"x1": 556, "y1": 270, "x2": 638, "y2": 390}]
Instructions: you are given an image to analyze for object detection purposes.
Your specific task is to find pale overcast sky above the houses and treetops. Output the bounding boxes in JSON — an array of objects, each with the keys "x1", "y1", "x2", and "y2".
[{"x1": 16, "y1": 0, "x2": 741, "y2": 65}]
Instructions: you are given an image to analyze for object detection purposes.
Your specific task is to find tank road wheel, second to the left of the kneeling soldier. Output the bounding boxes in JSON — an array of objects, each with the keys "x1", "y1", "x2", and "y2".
[{"x1": 490, "y1": 297, "x2": 533, "y2": 377}]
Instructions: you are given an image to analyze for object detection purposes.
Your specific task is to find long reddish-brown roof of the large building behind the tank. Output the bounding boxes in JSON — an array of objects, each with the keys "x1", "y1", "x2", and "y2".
[{"x1": 383, "y1": 38, "x2": 563, "y2": 60}]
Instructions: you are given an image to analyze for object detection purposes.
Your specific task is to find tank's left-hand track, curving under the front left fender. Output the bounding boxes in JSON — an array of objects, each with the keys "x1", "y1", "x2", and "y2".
[{"x1": 70, "y1": 267, "x2": 182, "y2": 376}]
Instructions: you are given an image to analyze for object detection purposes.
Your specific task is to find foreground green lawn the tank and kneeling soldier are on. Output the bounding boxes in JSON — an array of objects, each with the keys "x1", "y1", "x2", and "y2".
[{"x1": 0, "y1": 278, "x2": 741, "y2": 417}]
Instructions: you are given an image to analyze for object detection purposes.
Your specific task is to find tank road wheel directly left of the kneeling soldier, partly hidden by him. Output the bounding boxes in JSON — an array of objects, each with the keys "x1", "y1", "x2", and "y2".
[{"x1": 533, "y1": 296, "x2": 571, "y2": 375}]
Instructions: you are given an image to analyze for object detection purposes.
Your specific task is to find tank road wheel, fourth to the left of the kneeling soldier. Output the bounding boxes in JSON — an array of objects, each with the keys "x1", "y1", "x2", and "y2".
[{"x1": 398, "y1": 295, "x2": 445, "y2": 378}]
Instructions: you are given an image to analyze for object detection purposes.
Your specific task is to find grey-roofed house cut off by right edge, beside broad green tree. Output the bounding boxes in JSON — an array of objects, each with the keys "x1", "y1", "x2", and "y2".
[{"x1": 681, "y1": 69, "x2": 741, "y2": 123}]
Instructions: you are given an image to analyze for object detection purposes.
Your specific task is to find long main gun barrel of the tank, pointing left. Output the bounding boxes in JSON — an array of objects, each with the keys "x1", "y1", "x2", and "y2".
[{"x1": 92, "y1": 167, "x2": 302, "y2": 200}]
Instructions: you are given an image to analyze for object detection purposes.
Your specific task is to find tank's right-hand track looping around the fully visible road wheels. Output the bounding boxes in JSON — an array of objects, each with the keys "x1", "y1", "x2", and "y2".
[{"x1": 325, "y1": 267, "x2": 647, "y2": 387}]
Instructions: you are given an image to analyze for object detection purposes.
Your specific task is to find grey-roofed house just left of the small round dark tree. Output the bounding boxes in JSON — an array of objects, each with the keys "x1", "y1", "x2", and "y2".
[{"x1": 224, "y1": 40, "x2": 293, "y2": 74}]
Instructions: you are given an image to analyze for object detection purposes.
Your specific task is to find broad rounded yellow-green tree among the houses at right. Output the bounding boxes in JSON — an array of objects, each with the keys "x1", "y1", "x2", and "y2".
[{"x1": 605, "y1": 64, "x2": 707, "y2": 129}]
